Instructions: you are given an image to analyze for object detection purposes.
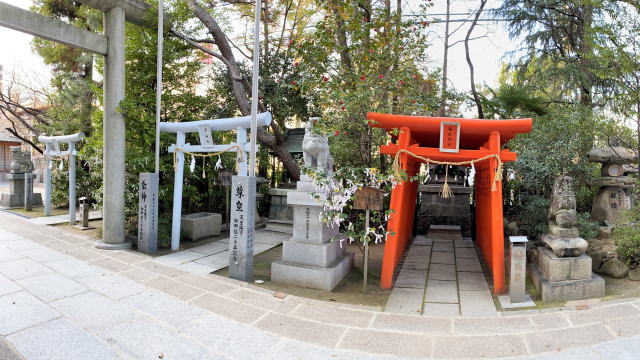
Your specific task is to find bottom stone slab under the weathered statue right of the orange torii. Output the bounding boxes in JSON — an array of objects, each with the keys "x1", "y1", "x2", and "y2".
[{"x1": 529, "y1": 264, "x2": 605, "y2": 303}]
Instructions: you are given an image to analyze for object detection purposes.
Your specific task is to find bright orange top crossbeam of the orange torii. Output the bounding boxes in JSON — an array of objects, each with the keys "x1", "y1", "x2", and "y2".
[{"x1": 367, "y1": 112, "x2": 532, "y2": 149}]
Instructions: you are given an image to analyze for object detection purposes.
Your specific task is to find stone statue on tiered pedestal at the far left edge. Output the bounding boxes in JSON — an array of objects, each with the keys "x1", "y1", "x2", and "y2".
[{"x1": 0, "y1": 146, "x2": 42, "y2": 208}]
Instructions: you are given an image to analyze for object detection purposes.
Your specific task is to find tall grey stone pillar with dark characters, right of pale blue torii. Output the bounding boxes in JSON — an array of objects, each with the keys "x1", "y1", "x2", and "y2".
[{"x1": 229, "y1": 176, "x2": 256, "y2": 281}]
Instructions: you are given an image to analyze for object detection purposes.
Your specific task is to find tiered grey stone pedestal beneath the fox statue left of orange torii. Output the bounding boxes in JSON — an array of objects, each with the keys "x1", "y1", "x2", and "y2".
[{"x1": 271, "y1": 176, "x2": 353, "y2": 291}]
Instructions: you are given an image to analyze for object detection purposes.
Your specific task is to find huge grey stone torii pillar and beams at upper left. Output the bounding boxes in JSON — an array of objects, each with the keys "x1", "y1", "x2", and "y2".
[{"x1": 0, "y1": 0, "x2": 149, "y2": 249}]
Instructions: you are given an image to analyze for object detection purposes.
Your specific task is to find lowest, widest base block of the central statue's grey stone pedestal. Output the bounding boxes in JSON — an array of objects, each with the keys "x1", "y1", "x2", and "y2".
[{"x1": 271, "y1": 254, "x2": 353, "y2": 291}]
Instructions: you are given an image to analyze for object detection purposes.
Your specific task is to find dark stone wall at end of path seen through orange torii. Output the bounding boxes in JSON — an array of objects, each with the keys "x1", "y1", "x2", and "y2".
[{"x1": 416, "y1": 184, "x2": 472, "y2": 237}]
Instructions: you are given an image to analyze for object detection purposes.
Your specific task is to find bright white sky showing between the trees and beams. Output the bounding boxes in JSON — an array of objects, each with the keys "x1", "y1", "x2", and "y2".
[{"x1": 0, "y1": 0, "x2": 515, "y2": 102}]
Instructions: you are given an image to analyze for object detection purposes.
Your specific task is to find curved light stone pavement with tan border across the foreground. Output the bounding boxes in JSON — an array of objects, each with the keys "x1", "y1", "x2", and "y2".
[{"x1": 0, "y1": 213, "x2": 640, "y2": 360}]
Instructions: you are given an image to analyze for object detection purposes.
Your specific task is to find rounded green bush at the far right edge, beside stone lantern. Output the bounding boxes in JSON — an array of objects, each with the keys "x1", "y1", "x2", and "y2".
[{"x1": 613, "y1": 206, "x2": 640, "y2": 268}]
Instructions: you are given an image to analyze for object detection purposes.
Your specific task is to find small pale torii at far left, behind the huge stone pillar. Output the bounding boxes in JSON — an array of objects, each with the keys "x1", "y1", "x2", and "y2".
[{"x1": 38, "y1": 132, "x2": 84, "y2": 225}]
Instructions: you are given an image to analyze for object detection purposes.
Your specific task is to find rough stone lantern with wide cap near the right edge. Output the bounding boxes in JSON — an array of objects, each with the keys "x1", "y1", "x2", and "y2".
[{"x1": 588, "y1": 147, "x2": 637, "y2": 233}]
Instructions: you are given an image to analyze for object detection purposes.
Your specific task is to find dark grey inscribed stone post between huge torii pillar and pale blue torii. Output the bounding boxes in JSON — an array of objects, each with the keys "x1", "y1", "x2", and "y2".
[{"x1": 138, "y1": 173, "x2": 158, "y2": 252}]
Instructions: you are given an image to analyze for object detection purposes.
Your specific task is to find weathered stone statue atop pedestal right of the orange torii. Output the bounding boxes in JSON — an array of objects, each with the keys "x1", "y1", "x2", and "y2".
[{"x1": 549, "y1": 176, "x2": 577, "y2": 229}]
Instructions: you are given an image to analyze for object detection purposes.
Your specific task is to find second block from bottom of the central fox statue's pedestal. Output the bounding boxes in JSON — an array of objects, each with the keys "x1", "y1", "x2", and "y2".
[{"x1": 282, "y1": 239, "x2": 347, "y2": 267}]
